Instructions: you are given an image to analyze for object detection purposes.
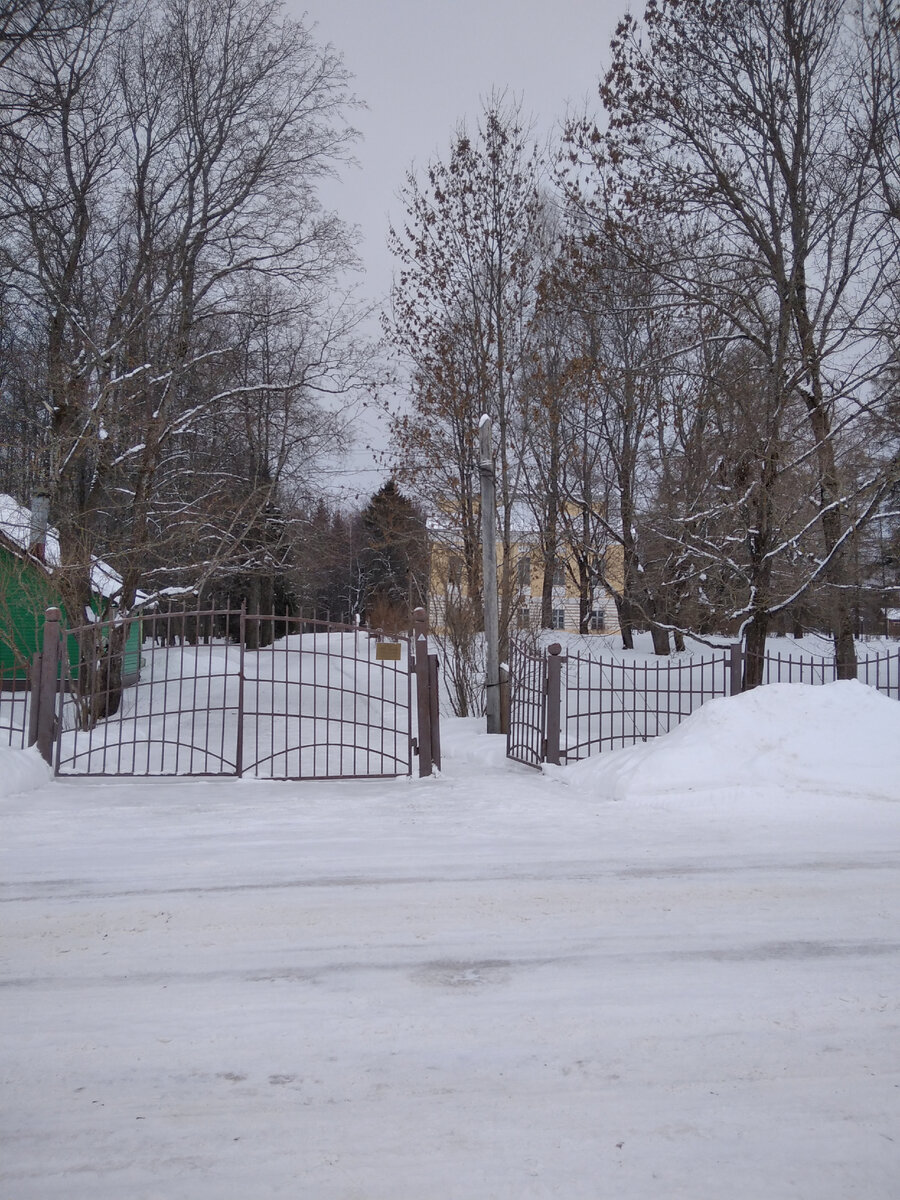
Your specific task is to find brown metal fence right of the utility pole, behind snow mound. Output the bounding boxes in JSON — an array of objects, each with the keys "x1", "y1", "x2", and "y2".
[{"x1": 506, "y1": 637, "x2": 900, "y2": 767}]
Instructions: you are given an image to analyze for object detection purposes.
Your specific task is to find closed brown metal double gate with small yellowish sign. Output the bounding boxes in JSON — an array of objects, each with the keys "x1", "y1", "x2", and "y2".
[{"x1": 37, "y1": 608, "x2": 439, "y2": 779}]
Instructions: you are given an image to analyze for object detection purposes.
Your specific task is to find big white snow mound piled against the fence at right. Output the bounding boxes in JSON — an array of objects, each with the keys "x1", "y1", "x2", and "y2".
[{"x1": 559, "y1": 680, "x2": 900, "y2": 800}]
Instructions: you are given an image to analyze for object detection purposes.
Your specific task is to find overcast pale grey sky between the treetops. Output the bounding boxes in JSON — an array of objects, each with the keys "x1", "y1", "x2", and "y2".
[{"x1": 287, "y1": 0, "x2": 628, "y2": 499}]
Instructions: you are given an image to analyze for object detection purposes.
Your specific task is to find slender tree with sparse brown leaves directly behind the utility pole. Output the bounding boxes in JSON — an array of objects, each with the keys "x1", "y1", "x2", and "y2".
[{"x1": 385, "y1": 96, "x2": 544, "y2": 657}]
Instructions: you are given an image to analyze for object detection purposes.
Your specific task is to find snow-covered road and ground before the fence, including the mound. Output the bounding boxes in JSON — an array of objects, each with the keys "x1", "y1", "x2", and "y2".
[{"x1": 0, "y1": 683, "x2": 900, "y2": 1200}]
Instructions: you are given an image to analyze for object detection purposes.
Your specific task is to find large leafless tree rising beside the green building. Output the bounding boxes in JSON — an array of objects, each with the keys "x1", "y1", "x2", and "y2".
[{"x1": 0, "y1": 0, "x2": 367, "y2": 720}]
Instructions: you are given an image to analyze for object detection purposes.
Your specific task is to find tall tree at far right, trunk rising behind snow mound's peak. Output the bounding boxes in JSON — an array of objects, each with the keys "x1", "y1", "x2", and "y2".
[{"x1": 573, "y1": 0, "x2": 892, "y2": 677}]
